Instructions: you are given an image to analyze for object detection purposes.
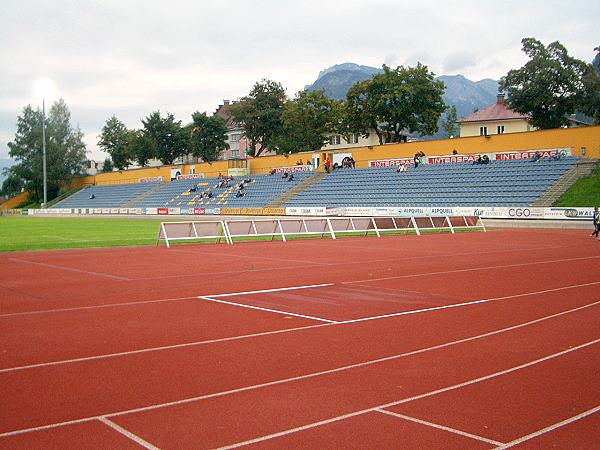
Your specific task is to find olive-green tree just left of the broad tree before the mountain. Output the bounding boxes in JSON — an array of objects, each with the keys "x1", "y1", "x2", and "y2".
[{"x1": 277, "y1": 91, "x2": 339, "y2": 154}]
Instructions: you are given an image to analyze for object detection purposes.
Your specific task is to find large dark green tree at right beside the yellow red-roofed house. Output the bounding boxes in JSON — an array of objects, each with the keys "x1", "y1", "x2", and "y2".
[{"x1": 500, "y1": 38, "x2": 595, "y2": 129}]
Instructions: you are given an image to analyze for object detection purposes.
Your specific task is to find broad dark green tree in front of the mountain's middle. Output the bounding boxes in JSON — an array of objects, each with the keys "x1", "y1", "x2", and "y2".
[{"x1": 347, "y1": 63, "x2": 445, "y2": 144}]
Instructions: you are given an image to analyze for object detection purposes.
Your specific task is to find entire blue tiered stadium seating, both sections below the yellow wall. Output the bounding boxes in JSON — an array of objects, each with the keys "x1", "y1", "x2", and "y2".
[{"x1": 54, "y1": 157, "x2": 578, "y2": 208}]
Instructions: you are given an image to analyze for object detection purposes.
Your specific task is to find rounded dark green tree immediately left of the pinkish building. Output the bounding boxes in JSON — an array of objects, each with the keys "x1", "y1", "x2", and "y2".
[{"x1": 189, "y1": 111, "x2": 227, "y2": 162}]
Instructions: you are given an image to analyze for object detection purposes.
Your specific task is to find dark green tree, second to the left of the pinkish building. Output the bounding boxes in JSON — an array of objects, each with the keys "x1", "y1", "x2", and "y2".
[{"x1": 142, "y1": 111, "x2": 188, "y2": 164}]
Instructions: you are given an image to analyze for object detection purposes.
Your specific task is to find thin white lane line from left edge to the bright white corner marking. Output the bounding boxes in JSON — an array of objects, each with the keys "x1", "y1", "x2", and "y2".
[{"x1": 0, "y1": 323, "x2": 331, "y2": 373}]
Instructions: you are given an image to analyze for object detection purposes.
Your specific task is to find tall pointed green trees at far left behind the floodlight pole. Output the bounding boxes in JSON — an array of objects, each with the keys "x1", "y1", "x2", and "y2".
[{"x1": 8, "y1": 99, "x2": 86, "y2": 201}]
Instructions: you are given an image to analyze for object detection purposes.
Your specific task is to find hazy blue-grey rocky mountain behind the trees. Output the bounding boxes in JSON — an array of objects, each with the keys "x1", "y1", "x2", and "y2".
[{"x1": 306, "y1": 63, "x2": 498, "y2": 122}]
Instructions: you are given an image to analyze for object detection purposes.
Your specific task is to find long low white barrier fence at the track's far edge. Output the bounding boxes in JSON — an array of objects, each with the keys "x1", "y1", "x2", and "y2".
[{"x1": 157, "y1": 216, "x2": 486, "y2": 247}]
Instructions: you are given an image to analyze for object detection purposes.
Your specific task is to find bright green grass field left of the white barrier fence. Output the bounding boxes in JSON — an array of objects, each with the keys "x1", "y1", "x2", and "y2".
[{"x1": 0, "y1": 216, "x2": 161, "y2": 252}]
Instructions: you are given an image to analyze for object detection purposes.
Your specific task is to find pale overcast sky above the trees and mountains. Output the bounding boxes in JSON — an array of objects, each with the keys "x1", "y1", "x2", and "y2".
[{"x1": 0, "y1": 0, "x2": 600, "y2": 160}]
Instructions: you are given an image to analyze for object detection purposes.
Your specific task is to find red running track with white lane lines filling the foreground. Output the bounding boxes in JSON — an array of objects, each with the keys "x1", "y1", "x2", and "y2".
[{"x1": 0, "y1": 230, "x2": 600, "y2": 449}]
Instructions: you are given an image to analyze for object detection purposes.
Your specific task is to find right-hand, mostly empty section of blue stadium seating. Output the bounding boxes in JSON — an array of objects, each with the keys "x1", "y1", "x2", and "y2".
[{"x1": 286, "y1": 157, "x2": 577, "y2": 207}]
